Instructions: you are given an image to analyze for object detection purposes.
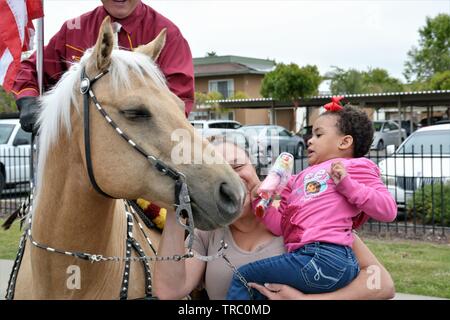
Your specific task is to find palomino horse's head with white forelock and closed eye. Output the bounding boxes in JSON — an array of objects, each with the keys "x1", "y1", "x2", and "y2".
[{"x1": 38, "y1": 17, "x2": 245, "y2": 230}]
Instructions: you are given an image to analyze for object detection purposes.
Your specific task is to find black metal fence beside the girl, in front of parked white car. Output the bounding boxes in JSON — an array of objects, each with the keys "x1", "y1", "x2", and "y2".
[{"x1": 255, "y1": 145, "x2": 450, "y2": 238}]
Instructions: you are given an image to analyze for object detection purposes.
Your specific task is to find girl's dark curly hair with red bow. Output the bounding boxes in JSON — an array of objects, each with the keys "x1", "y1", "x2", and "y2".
[{"x1": 321, "y1": 105, "x2": 373, "y2": 158}]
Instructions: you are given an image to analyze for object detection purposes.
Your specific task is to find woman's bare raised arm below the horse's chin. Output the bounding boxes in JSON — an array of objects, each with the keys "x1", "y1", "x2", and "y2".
[{"x1": 153, "y1": 212, "x2": 206, "y2": 300}]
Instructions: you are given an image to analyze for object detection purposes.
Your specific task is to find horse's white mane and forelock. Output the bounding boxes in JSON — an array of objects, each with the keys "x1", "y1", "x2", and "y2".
[{"x1": 37, "y1": 49, "x2": 167, "y2": 202}]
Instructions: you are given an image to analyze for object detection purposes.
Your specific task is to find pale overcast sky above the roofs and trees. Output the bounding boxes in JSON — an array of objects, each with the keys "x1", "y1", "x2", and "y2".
[{"x1": 39, "y1": 0, "x2": 450, "y2": 89}]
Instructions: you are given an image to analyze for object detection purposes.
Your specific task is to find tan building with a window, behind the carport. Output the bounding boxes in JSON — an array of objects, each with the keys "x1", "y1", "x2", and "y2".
[{"x1": 189, "y1": 55, "x2": 275, "y2": 124}]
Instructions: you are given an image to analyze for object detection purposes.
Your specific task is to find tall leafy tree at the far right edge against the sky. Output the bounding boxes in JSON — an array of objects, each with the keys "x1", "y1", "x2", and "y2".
[{"x1": 403, "y1": 13, "x2": 450, "y2": 82}]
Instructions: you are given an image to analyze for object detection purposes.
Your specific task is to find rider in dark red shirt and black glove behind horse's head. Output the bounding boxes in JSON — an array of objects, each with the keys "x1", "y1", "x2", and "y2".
[{"x1": 12, "y1": 0, "x2": 194, "y2": 226}]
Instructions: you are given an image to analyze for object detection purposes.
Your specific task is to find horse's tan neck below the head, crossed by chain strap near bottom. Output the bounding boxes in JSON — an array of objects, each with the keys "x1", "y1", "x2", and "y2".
[{"x1": 30, "y1": 131, "x2": 126, "y2": 299}]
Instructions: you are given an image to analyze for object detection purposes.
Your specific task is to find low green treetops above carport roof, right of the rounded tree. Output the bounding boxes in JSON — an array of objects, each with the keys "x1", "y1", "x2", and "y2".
[{"x1": 325, "y1": 67, "x2": 403, "y2": 95}]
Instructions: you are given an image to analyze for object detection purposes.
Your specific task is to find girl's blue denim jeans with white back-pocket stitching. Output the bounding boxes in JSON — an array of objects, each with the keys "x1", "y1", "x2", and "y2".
[{"x1": 227, "y1": 242, "x2": 360, "y2": 300}]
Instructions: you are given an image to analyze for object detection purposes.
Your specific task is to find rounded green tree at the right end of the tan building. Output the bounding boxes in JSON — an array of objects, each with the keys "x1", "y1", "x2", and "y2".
[{"x1": 261, "y1": 63, "x2": 322, "y2": 107}]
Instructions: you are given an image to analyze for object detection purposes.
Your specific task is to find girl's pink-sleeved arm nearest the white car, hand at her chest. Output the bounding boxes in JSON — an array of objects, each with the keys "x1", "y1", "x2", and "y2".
[{"x1": 331, "y1": 159, "x2": 397, "y2": 222}]
